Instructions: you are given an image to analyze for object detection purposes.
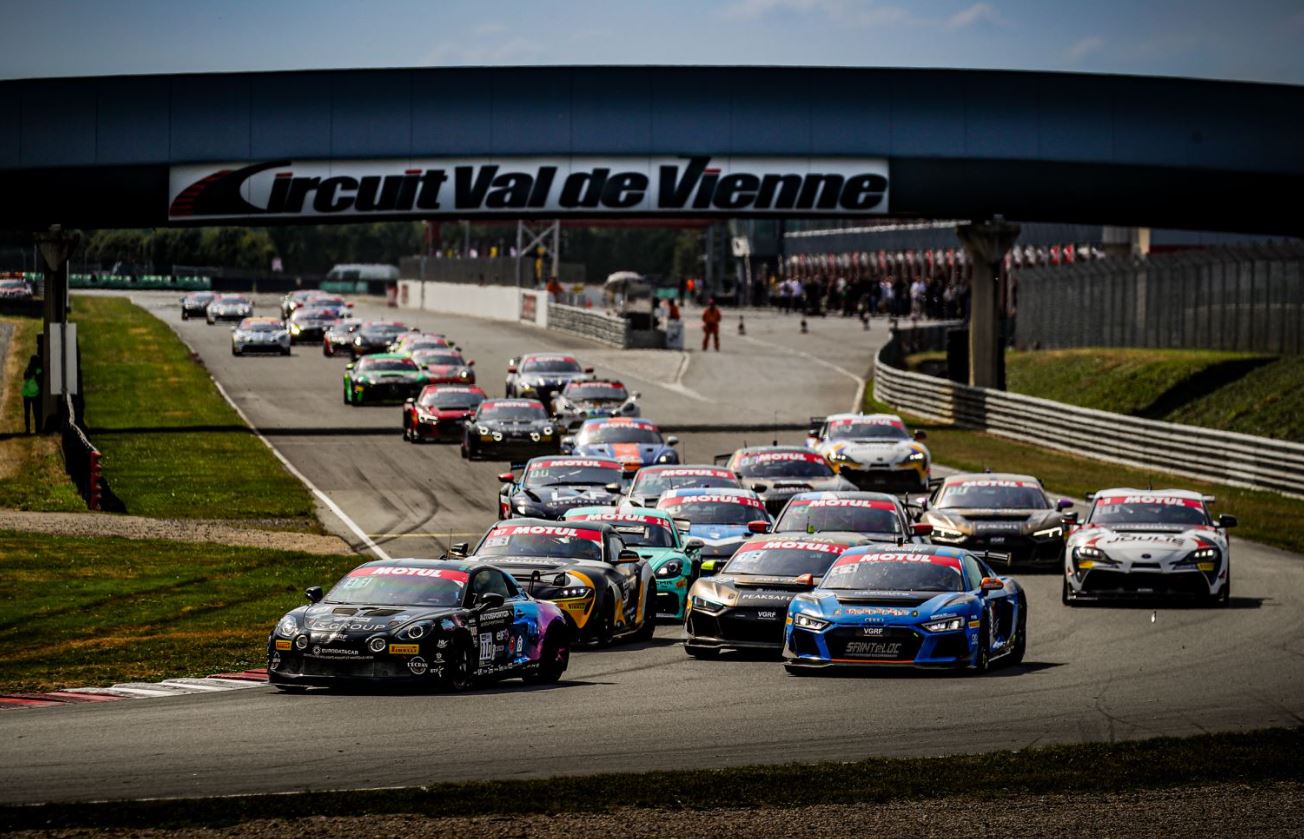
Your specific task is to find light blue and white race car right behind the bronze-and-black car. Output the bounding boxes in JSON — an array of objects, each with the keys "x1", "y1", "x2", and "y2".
[{"x1": 652, "y1": 488, "x2": 773, "y2": 574}]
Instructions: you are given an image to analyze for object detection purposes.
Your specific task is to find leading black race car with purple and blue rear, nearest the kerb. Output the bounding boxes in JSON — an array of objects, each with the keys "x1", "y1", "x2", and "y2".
[{"x1": 267, "y1": 560, "x2": 570, "y2": 692}]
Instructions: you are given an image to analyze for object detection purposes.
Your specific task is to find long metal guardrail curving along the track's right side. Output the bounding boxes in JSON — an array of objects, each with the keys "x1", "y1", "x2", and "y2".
[{"x1": 874, "y1": 330, "x2": 1304, "y2": 496}]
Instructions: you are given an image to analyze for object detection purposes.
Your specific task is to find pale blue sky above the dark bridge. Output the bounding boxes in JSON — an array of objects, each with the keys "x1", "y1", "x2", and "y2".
[{"x1": 0, "y1": 0, "x2": 1304, "y2": 85}]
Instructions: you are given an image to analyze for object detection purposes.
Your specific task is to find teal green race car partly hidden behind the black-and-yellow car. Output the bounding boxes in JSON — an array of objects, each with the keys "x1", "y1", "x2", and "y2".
[{"x1": 562, "y1": 506, "x2": 702, "y2": 621}]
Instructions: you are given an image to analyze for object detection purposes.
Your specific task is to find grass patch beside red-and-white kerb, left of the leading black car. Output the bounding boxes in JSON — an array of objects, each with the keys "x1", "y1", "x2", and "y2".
[{"x1": 0, "y1": 531, "x2": 360, "y2": 690}]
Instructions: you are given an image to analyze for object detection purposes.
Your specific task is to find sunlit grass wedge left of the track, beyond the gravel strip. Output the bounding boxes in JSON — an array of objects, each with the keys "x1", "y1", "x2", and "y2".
[{"x1": 73, "y1": 296, "x2": 318, "y2": 519}]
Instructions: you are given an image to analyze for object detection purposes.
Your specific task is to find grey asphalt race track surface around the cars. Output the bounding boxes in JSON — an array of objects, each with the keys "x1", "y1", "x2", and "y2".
[{"x1": 0, "y1": 295, "x2": 1304, "y2": 802}]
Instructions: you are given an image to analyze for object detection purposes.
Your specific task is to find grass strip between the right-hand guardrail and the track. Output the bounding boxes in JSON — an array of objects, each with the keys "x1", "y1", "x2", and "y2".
[{"x1": 865, "y1": 389, "x2": 1304, "y2": 552}]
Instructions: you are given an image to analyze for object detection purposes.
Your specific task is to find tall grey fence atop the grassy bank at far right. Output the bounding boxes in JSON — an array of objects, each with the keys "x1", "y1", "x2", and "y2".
[{"x1": 1015, "y1": 245, "x2": 1304, "y2": 355}]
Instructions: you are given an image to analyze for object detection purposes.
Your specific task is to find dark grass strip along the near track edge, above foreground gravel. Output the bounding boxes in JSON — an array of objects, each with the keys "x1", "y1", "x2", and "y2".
[{"x1": 0, "y1": 728, "x2": 1304, "y2": 830}]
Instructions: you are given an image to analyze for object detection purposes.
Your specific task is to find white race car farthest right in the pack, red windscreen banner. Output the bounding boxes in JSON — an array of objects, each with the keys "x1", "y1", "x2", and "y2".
[{"x1": 1063, "y1": 488, "x2": 1236, "y2": 605}]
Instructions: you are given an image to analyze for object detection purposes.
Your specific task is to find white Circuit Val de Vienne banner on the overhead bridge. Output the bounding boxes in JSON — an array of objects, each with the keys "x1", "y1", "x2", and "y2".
[{"x1": 168, "y1": 155, "x2": 888, "y2": 219}]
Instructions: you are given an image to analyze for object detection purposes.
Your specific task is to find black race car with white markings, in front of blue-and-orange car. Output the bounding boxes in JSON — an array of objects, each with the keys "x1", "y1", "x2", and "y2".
[{"x1": 498, "y1": 455, "x2": 621, "y2": 519}]
